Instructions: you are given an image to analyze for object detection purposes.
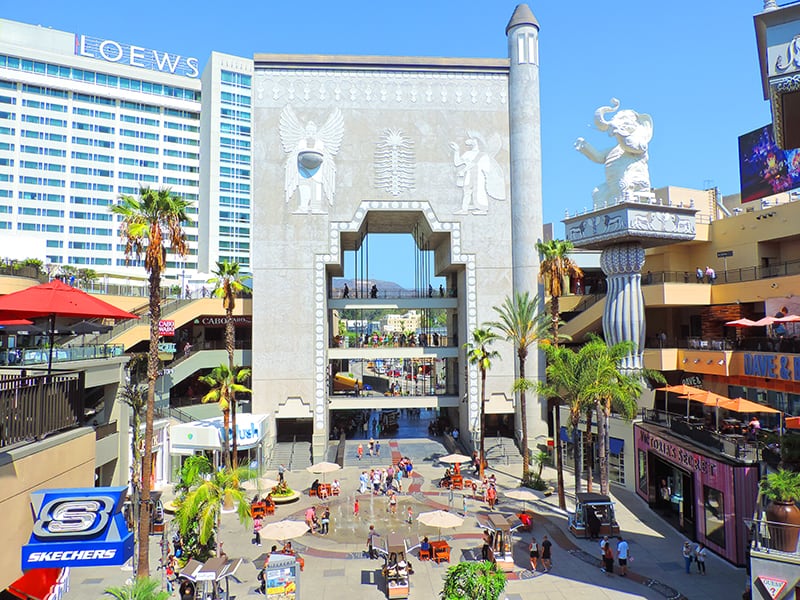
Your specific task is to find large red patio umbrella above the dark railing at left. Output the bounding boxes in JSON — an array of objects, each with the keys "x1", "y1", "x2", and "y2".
[{"x1": 0, "y1": 279, "x2": 139, "y2": 373}]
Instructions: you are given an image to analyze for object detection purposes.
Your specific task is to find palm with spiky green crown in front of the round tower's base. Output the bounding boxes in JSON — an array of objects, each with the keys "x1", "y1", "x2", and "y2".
[{"x1": 487, "y1": 292, "x2": 547, "y2": 485}]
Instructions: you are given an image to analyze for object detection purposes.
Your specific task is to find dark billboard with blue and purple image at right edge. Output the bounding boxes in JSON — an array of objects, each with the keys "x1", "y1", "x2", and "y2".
[{"x1": 739, "y1": 124, "x2": 800, "y2": 204}]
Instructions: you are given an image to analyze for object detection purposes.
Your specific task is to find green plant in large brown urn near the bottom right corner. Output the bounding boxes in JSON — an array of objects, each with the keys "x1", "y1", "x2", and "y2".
[{"x1": 760, "y1": 469, "x2": 800, "y2": 552}]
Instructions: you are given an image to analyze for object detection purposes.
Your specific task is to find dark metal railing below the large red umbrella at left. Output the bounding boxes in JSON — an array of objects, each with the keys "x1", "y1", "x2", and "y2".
[{"x1": 0, "y1": 372, "x2": 84, "y2": 448}]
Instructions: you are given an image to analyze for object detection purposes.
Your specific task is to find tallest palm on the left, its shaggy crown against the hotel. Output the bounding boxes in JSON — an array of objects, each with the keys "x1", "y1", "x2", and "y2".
[{"x1": 111, "y1": 187, "x2": 189, "y2": 577}]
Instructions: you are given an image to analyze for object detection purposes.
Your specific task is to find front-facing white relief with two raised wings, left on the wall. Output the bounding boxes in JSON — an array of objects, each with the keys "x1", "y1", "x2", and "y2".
[{"x1": 280, "y1": 106, "x2": 344, "y2": 213}]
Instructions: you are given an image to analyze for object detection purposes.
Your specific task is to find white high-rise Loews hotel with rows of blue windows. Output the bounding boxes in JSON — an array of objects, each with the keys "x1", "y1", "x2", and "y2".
[{"x1": 0, "y1": 19, "x2": 253, "y2": 278}]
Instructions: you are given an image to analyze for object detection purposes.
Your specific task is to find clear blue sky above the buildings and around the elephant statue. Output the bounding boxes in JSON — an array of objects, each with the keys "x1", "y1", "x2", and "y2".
[{"x1": 1, "y1": 0, "x2": 784, "y2": 288}]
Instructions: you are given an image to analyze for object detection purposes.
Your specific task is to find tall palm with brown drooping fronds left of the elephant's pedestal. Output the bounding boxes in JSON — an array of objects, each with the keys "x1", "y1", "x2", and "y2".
[{"x1": 536, "y1": 240, "x2": 583, "y2": 510}]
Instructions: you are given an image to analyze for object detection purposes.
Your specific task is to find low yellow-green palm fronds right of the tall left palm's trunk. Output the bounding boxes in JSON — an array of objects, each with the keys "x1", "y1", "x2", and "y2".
[{"x1": 175, "y1": 467, "x2": 256, "y2": 556}]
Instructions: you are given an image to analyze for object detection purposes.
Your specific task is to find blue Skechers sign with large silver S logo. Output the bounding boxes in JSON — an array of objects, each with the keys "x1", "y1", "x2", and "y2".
[{"x1": 22, "y1": 487, "x2": 133, "y2": 571}]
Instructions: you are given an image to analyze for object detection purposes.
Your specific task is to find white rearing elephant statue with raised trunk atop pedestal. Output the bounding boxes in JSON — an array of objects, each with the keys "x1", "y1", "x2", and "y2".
[{"x1": 575, "y1": 98, "x2": 653, "y2": 208}]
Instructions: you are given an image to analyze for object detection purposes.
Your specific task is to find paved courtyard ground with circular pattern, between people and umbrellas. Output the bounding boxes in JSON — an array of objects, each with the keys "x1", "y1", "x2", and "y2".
[{"x1": 59, "y1": 428, "x2": 746, "y2": 600}]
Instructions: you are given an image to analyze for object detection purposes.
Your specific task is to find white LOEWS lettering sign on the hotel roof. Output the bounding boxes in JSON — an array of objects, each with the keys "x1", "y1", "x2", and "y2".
[{"x1": 75, "y1": 35, "x2": 200, "y2": 77}]
